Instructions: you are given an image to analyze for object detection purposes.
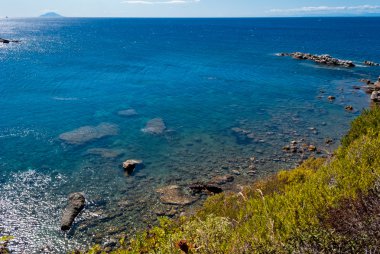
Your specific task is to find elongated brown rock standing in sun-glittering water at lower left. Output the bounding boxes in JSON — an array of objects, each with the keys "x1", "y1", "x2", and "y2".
[{"x1": 61, "y1": 192, "x2": 86, "y2": 231}]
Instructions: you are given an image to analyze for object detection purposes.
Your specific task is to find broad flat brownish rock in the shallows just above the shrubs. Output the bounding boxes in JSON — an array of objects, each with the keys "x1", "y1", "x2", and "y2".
[{"x1": 156, "y1": 185, "x2": 198, "y2": 205}]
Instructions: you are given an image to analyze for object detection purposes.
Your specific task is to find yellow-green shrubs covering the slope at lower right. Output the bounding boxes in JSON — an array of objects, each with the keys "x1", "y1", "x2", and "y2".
[{"x1": 84, "y1": 107, "x2": 380, "y2": 253}]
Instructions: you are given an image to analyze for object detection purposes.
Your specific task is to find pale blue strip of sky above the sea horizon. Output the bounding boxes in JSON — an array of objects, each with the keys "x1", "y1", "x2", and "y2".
[{"x1": 0, "y1": 0, "x2": 380, "y2": 17}]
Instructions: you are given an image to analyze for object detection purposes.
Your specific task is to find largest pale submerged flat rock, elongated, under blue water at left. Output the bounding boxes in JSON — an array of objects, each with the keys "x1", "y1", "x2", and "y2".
[{"x1": 59, "y1": 123, "x2": 119, "y2": 145}]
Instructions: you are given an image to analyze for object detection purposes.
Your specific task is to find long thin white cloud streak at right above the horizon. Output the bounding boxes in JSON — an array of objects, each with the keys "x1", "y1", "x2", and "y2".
[{"x1": 270, "y1": 5, "x2": 380, "y2": 13}]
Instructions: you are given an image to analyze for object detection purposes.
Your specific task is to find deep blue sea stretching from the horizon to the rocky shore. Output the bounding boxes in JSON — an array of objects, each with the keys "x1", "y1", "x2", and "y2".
[{"x1": 0, "y1": 18, "x2": 380, "y2": 253}]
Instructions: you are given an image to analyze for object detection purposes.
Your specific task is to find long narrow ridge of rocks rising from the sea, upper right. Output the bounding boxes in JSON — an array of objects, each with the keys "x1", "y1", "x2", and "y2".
[{"x1": 277, "y1": 52, "x2": 355, "y2": 68}]
